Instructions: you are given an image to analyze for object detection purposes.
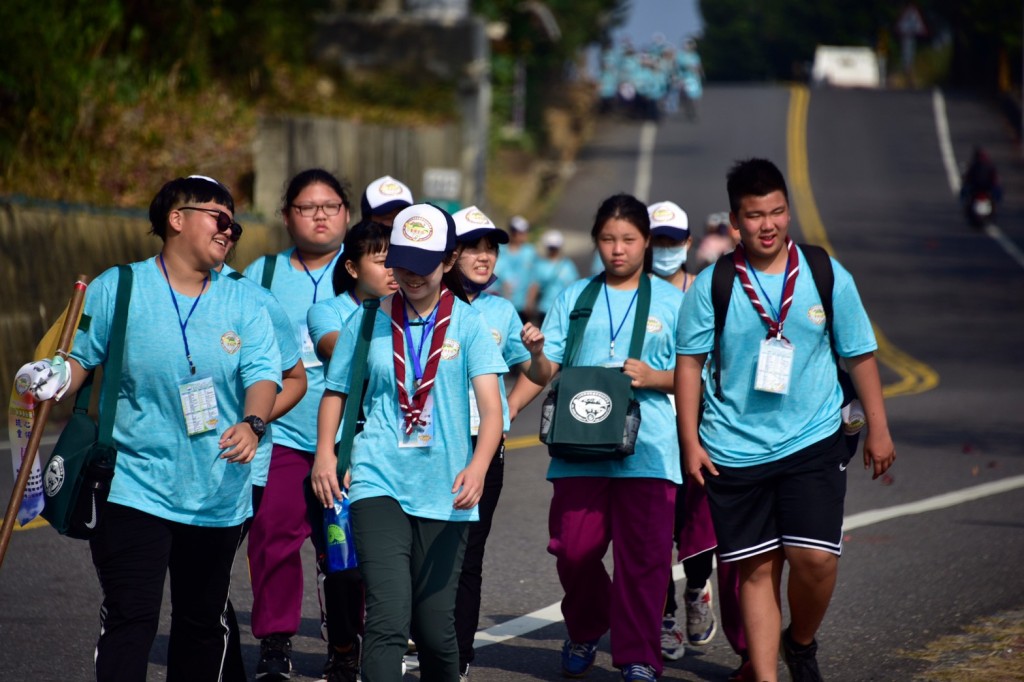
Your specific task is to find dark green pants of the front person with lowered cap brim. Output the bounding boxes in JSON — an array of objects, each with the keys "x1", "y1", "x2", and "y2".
[{"x1": 351, "y1": 498, "x2": 469, "y2": 682}]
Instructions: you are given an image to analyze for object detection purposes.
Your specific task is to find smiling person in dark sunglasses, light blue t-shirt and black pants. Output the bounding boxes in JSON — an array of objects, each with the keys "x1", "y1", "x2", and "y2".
[{"x1": 17, "y1": 176, "x2": 281, "y2": 682}]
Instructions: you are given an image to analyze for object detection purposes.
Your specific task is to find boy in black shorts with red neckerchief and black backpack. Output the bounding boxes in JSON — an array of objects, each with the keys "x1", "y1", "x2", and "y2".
[{"x1": 675, "y1": 159, "x2": 896, "y2": 680}]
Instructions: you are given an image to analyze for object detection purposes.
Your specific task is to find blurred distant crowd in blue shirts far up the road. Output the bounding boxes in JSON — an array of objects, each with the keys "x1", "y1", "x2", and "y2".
[{"x1": 598, "y1": 34, "x2": 705, "y2": 121}]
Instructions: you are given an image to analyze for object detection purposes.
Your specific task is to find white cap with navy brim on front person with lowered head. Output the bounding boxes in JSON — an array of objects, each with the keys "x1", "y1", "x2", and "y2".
[{"x1": 384, "y1": 204, "x2": 455, "y2": 276}]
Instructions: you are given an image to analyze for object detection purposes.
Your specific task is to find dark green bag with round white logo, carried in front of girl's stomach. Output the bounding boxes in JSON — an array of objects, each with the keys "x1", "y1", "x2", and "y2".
[{"x1": 540, "y1": 274, "x2": 650, "y2": 462}]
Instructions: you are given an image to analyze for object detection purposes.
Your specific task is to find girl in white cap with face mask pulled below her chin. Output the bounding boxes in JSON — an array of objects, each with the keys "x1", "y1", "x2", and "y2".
[{"x1": 453, "y1": 206, "x2": 557, "y2": 682}]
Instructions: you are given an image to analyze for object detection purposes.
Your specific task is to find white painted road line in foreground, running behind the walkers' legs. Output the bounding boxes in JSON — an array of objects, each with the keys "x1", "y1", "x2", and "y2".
[{"x1": 473, "y1": 476, "x2": 1024, "y2": 648}]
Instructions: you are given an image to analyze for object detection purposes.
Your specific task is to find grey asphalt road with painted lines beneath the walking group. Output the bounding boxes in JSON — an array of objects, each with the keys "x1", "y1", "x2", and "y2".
[{"x1": 0, "y1": 86, "x2": 1024, "y2": 682}]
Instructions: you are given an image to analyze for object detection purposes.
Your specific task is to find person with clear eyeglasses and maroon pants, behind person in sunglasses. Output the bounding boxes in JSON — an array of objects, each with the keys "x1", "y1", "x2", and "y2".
[{"x1": 239, "y1": 168, "x2": 349, "y2": 679}]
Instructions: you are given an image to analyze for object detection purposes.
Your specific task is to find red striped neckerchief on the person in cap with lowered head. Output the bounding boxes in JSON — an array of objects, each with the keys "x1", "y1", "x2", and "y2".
[{"x1": 391, "y1": 285, "x2": 455, "y2": 435}]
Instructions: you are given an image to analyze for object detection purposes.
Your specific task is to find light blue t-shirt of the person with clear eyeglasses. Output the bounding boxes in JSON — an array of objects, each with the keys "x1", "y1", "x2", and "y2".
[{"x1": 245, "y1": 248, "x2": 340, "y2": 453}]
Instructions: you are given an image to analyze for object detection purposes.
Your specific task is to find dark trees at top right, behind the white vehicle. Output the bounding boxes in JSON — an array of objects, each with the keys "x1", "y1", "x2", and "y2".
[{"x1": 700, "y1": 0, "x2": 1024, "y2": 92}]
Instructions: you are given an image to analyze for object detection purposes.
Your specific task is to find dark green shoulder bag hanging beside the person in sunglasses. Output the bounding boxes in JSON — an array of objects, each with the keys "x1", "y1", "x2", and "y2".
[{"x1": 42, "y1": 265, "x2": 132, "y2": 540}]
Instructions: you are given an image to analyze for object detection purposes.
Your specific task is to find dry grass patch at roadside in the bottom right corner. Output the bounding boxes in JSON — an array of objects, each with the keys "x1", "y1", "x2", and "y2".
[{"x1": 906, "y1": 610, "x2": 1024, "y2": 682}]
